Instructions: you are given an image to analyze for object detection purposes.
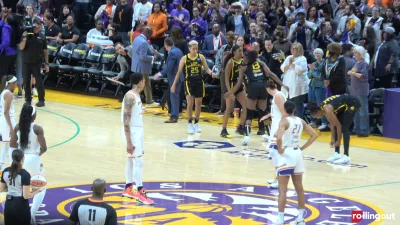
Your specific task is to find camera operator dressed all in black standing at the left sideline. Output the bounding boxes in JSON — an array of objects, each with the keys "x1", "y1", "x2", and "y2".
[{"x1": 19, "y1": 18, "x2": 49, "y2": 107}]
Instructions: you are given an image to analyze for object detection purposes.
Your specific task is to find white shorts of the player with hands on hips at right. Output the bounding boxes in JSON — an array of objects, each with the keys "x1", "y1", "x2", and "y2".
[{"x1": 275, "y1": 147, "x2": 304, "y2": 176}]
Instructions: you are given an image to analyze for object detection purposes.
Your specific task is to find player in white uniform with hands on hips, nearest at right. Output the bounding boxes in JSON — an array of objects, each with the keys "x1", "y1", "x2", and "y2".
[{"x1": 275, "y1": 101, "x2": 318, "y2": 225}]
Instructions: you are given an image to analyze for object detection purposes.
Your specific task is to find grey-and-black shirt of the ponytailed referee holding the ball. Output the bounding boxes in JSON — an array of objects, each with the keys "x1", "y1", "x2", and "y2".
[{"x1": 1, "y1": 167, "x2": 31, "y2": 197}]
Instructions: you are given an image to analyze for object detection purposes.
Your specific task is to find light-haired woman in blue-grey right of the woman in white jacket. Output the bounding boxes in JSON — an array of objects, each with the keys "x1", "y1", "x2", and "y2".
[{"x1": 308, "y1": 48, "x2": 328, "y2": 130}]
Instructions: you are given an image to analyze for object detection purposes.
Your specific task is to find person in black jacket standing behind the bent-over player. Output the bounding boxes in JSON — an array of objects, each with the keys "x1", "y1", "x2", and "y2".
[{"x1": 322, "y1": 42, "x2": 347, "y2": 97}]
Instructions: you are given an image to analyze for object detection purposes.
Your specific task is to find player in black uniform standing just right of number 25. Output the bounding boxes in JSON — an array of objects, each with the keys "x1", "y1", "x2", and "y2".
[{"x1": 220, "y1": 45, "x2": 247, "y2": 138}]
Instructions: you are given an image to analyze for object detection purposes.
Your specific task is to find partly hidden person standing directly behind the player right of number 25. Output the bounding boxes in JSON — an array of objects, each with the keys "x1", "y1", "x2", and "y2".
[{"x1": 215, "y1": 31, "x2": 235, "y2": 116}]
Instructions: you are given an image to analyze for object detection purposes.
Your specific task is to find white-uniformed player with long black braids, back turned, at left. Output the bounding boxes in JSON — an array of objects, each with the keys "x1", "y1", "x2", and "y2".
[{"x1": 10, "y1": 103, "x2": 47, "y2": 224}]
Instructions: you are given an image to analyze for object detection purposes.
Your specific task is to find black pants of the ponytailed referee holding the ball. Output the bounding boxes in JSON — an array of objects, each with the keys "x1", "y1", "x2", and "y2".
[{"x1": 4, "y1": 197, "x2": 31, "y2": 225}]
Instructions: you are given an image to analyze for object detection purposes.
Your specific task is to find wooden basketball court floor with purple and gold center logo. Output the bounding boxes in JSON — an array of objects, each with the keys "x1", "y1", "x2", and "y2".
[{"x1": 1, "y1": 91, "x2": 400, "y2": 225}]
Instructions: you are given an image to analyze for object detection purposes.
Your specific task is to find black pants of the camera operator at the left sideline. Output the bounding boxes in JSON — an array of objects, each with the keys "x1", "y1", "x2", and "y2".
[{"x1": 22, "y1": 63, "x2": 44, "y2": 102}]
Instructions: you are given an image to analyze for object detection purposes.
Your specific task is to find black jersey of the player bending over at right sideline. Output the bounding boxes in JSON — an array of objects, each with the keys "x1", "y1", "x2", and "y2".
[{"x1": 321, "y1": 95, "x2": 359, "y2": 114}]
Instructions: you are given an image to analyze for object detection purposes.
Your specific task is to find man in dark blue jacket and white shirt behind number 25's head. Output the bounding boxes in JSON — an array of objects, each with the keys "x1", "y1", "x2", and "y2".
[{"x1": 202, "y1": 24, "x2": 226, "y2": 61}]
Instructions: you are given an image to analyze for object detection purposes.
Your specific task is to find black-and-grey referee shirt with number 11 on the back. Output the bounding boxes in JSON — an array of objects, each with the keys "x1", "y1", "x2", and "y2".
[{"x1": 69, "y1": 198, "x2": 118, "y2": 225}]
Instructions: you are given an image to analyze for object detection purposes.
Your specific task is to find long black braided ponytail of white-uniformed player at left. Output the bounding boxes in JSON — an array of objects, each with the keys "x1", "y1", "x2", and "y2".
[{"x1": 18, "y1": 103, "x2": 35, "y2": 150}]
